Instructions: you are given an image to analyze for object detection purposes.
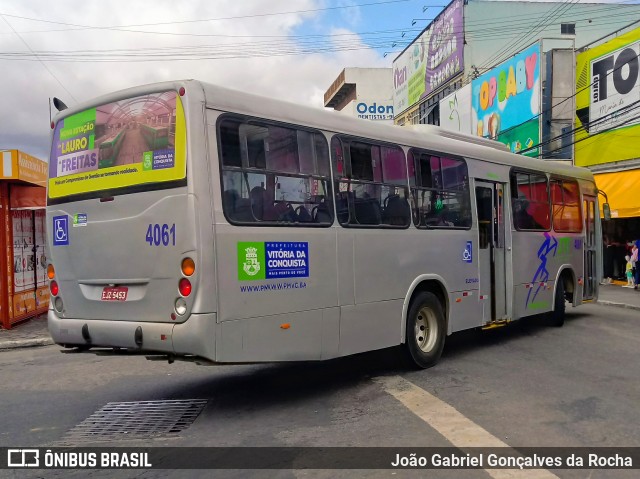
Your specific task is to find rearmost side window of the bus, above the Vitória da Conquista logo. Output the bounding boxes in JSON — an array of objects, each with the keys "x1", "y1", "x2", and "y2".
[{"x1": 218, "y1": 115, "x2": 333, "y2": 226}]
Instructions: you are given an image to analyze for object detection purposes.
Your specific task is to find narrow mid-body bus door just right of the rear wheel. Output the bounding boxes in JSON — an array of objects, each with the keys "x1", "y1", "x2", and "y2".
[{"x1": 476, "y1": 181, "x2": 507, "y2": 322}]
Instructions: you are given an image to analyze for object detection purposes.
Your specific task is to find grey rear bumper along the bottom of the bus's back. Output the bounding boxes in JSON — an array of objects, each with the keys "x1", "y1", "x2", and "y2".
[{"x1": 47, "y1": 309, "x2": 216, "y2": 361}]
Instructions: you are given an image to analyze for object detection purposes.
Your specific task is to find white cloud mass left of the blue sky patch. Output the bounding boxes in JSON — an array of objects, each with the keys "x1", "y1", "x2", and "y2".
[{"x1": 0, "y1": 0, "x2": 388, "y2": 159}]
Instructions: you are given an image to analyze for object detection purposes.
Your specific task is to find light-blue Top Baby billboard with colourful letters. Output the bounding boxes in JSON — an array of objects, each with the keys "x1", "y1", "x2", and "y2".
[{"x1": 471, "y1": 43, "x2": 540, "y2": 157}]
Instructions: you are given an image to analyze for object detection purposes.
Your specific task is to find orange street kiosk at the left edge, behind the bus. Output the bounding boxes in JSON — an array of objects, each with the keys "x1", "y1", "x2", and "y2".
[{"x1": 0, "y1": 150, "x2": 49, "y2": 329}]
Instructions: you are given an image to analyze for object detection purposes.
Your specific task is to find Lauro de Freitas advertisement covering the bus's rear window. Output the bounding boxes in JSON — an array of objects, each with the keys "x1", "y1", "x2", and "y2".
[{"x1": 49, "y1": 91, "x2": 186, "y2": 198}]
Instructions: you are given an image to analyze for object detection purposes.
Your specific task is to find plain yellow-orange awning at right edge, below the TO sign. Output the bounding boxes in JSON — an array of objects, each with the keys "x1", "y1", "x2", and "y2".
[{"x1": 594, "y1": 169, "x2": 640, "y2": 218}]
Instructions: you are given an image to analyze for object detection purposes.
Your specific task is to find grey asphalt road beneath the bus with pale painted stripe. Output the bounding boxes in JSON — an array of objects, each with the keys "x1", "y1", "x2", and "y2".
[{"x1": 0, "y1": 305, "x2": 640, "y2": 479}]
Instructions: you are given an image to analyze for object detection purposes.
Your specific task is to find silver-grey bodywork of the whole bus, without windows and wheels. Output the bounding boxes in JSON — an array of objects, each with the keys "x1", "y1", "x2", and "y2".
[{"x1": 47, "y1": 81, "x2": 600, "y2": 362}]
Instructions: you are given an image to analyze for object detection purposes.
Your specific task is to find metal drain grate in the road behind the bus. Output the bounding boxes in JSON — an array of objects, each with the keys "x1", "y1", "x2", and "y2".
[{"x1": 61, "y1": 399, "x2": 207, "y2": 444}]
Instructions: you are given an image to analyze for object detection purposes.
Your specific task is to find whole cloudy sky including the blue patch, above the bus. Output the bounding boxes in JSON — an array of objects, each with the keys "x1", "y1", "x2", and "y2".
[{"x1": 0, "y1": 0, "x2": 639, "y2": 159}]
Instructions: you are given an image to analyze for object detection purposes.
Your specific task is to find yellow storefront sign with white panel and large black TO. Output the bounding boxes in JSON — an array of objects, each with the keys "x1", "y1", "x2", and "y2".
[{"x1": 575, "y1": 28, "x2": 640, "y2": 166}]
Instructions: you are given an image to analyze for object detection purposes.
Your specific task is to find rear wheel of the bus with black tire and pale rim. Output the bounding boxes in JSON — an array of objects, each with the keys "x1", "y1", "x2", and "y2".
[{"x1": 405, "y1": 291, "x2": 447, "y2": 369}]
